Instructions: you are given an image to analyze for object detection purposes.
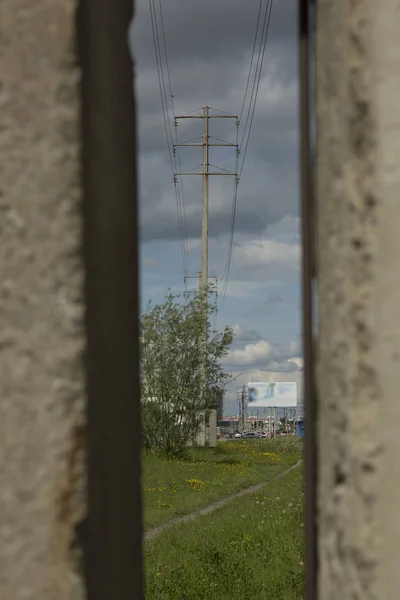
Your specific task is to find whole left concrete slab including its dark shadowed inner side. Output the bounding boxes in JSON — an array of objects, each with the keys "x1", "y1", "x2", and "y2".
[{"x1": 0, "y1": 0, "x2": 142, "y2": 600}]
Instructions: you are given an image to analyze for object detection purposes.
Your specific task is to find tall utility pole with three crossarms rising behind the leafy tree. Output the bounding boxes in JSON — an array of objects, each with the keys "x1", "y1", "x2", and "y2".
[{"x1": 173, "y1": 106, "x2": 239, "y2": 448}]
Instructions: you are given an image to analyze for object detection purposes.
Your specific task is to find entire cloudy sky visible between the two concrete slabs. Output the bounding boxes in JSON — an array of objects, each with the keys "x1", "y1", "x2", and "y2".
[{"x1": 130, "y1": 0, "x2": 303, "y2": 414}]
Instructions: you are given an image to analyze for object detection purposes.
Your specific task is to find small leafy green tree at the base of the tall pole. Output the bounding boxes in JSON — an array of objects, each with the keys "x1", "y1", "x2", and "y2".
[{"x1": 141, "y1": 294, "x2": 233, "y2": 455}]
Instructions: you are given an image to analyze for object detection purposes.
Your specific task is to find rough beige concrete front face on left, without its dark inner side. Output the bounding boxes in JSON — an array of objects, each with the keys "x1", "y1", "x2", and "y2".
[{"x1": 0, "y1": 0, "x2": 85, "y2": 600}]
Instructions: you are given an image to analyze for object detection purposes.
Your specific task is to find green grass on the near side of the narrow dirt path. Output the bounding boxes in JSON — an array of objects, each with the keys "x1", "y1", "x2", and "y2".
[{"x1": 145, "y1": 467, "x2": 304, "y2": 600}]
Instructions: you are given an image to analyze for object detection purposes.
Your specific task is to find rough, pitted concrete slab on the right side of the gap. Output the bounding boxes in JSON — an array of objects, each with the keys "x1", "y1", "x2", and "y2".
[{"x1": 316, "y1": 0, "x2": 400, "y2": 600}]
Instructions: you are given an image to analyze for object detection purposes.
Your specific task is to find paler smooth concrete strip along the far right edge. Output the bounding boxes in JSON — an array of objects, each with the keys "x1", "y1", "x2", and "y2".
[{"x1": 372, "y1": 5, "x2": 400, "y2": 599}]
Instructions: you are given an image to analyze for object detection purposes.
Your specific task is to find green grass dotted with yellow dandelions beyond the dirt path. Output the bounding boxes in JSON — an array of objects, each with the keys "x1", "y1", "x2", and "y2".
[{"x1": 143, "y1": 438, "x2": 302, "y2": 530}]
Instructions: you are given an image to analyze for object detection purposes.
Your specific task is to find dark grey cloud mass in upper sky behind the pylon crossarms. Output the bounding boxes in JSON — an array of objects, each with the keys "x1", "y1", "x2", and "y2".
[{"x1": 132, "y1": 0, "x2": 298, "y2": 242}]
